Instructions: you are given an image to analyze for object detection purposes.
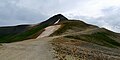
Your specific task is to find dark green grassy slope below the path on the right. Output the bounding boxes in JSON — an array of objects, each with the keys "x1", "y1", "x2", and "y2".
[{"x1": 65, "y1": 32, "x2": 120, "y2": 48}]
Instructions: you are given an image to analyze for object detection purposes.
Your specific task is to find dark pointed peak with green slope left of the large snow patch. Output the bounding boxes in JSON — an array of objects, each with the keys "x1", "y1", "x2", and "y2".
[{"x1": 0, "y1": 14, "x2": 68, "y2": 43}]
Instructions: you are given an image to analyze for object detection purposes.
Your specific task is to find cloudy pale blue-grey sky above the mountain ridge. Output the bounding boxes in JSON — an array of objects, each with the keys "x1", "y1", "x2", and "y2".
[{"x1": 0, "y1": 0, "x2": 120, "y2": 32}]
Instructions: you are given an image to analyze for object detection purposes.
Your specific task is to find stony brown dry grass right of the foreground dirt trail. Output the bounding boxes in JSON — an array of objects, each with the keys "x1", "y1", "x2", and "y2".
[{"x1": 51, "y1": 38, "x2": 120, "y2": 60}]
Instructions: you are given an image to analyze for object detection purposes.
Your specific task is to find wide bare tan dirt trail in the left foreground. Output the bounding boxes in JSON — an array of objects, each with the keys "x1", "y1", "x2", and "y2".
[{"x1": 0, "y1": 37, "x2": 54, "y2": 60}]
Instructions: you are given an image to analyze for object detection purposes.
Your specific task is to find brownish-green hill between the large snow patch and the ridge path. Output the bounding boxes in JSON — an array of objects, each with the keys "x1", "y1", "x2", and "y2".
[{"x1": 51, "y1": 20, "x2": 98, "y2": 36}]
